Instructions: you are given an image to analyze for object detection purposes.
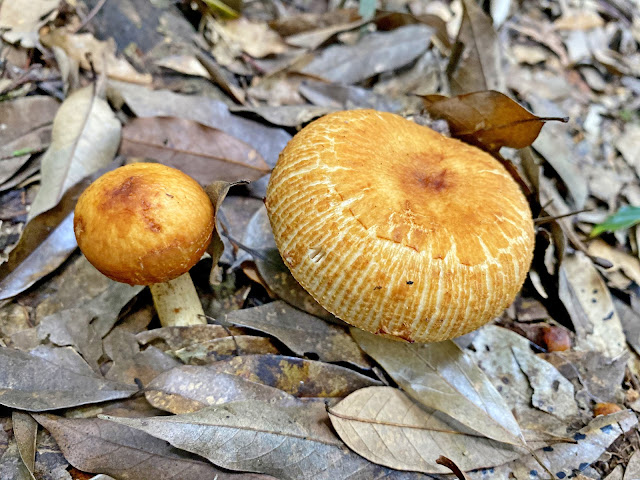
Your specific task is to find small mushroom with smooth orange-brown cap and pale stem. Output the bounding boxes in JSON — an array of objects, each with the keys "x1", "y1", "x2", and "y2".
[{"x1": 73, "y1": 163, "x2": 214, "y2": 326}]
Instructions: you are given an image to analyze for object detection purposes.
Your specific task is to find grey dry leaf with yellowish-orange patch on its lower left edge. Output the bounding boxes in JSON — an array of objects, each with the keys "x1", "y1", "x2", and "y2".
[{"x1": 145, "y1": 365, "x2": 295, "y2": 414}]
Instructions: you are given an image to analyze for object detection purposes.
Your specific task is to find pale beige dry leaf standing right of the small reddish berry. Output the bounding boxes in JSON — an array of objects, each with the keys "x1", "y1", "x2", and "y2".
[{"x1": 558, "y1": 252, "x2": 626, "y2": 358}]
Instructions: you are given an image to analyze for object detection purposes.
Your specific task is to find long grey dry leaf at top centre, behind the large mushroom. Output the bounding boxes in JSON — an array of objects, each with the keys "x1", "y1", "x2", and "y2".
[{"x1": 301, "y1": 25, "x2": 433, "y2": 84}]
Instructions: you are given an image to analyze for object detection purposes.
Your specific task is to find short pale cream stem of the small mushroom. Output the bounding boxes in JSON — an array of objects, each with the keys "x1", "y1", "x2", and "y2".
[{"x1": 149, "y1": 272, "x2": 207, "y2": 327}]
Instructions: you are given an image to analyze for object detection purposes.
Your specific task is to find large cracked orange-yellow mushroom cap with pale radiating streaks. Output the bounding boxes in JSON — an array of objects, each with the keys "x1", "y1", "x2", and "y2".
[{"x1": 265, "y1": 110, "x2": 534, "y2": 342}]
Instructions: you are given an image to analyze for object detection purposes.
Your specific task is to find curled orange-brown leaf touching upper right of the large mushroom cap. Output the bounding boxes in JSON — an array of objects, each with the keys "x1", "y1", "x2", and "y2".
[{"x1": 422, "y1": 90, "x2": 567, "y2": 152}]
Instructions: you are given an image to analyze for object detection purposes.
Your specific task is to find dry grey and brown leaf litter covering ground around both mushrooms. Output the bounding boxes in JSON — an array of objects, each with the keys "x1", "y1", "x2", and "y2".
[{"x1": 0, "y1": 0, "x2": 640, "y2": 480}]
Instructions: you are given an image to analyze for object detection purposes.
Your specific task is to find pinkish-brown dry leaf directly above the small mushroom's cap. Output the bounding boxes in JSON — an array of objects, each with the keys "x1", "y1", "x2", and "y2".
[{"x1": 120, "y1": 117, "x2": 269, "y2": 185}]
